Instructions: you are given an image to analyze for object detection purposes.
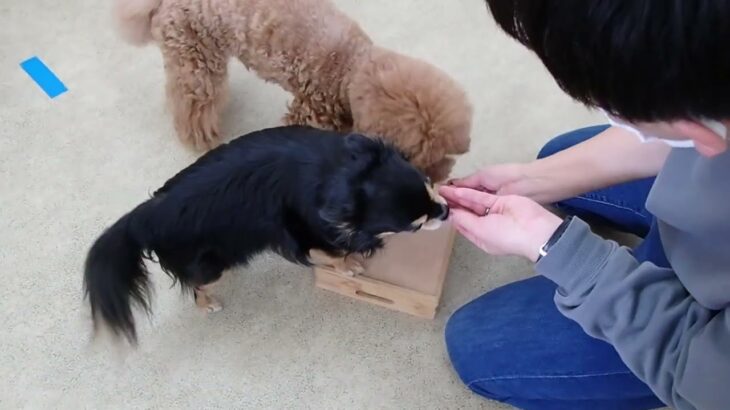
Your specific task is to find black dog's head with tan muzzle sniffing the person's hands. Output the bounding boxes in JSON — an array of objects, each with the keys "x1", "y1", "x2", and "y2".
[{"x1": 320, "y1": 134, "x2": 449, "y2": 252}]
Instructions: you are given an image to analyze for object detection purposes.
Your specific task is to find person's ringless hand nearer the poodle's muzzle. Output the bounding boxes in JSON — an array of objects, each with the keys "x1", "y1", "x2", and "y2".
[{"x1": 449, "y1": 163, "x2": 530, "y2": 196}]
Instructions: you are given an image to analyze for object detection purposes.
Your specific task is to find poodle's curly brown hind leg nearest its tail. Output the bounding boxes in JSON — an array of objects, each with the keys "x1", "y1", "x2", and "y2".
[{"x1": 163, "y1": 45, "x2": 227, "y2": 150}]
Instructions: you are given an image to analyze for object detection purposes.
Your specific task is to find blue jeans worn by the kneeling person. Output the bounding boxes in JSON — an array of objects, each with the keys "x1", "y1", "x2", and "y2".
[{"x1": 446, "y1": 126, "x2": 668, "y2": 410}]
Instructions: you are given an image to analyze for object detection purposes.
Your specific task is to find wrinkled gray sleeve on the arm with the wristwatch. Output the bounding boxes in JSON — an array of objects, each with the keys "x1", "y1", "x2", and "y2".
[{"x1": 536, "y1": 218, "x2": 730, "y2": 410}]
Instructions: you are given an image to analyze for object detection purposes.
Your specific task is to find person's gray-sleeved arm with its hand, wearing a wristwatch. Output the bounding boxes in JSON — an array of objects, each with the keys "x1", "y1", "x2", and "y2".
[{"x1": 439, "y1": 186, "x2": 730, "y2": 410}]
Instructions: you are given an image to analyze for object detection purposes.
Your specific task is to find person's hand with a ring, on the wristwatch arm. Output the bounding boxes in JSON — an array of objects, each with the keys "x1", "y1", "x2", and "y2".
[{"x1": 439, "y1": 186, "x2": 562, "y2": 262}]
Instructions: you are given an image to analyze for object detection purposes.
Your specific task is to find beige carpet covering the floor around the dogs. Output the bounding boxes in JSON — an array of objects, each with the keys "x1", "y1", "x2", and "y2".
[{"x1": 0, "y1": 0, "x2": 597, "y2": 409}]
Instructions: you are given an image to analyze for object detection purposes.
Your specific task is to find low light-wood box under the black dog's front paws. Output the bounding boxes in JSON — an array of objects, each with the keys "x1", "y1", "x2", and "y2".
[{"x1": 314, "y1": 224, "x2": 455, "y2": 319}]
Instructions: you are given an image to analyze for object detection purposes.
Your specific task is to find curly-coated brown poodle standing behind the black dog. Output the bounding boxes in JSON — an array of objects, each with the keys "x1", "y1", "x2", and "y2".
[{"x1": 115, "y1": 0, "x2": 472, "y2": 182}]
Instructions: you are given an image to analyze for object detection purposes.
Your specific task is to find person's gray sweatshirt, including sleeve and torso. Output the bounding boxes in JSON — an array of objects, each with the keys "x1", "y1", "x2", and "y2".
[{"x1": 536, "y1": 148, "x2": 730, "y2": 410}]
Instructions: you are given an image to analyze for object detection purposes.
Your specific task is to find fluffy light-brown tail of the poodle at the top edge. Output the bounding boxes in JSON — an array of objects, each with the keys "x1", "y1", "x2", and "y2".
[{"x1": 114, "y1": 0, "x2": 162, "y2": 46}]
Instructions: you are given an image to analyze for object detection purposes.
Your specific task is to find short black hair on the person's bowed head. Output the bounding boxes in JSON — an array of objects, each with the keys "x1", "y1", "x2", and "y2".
[{"x1": 487, "y1": 0, "x2": 730, "y2": 121}]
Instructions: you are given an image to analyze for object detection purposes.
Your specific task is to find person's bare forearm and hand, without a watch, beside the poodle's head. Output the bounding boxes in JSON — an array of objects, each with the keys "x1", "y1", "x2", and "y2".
[{"x1": 451, "y1": 127, "x2": 670, "y2": 204}]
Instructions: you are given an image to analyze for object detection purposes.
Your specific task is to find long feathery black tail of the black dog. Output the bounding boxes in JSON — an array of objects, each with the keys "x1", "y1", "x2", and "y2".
[{"x1": 84, "y1": 201, "x2": 151, "y2": 344}]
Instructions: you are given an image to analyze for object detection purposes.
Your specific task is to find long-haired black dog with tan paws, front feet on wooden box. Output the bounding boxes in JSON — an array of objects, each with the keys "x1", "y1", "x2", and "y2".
[{"x1": 84, "y1": 127, "x2": 448, "y2": 343}]
